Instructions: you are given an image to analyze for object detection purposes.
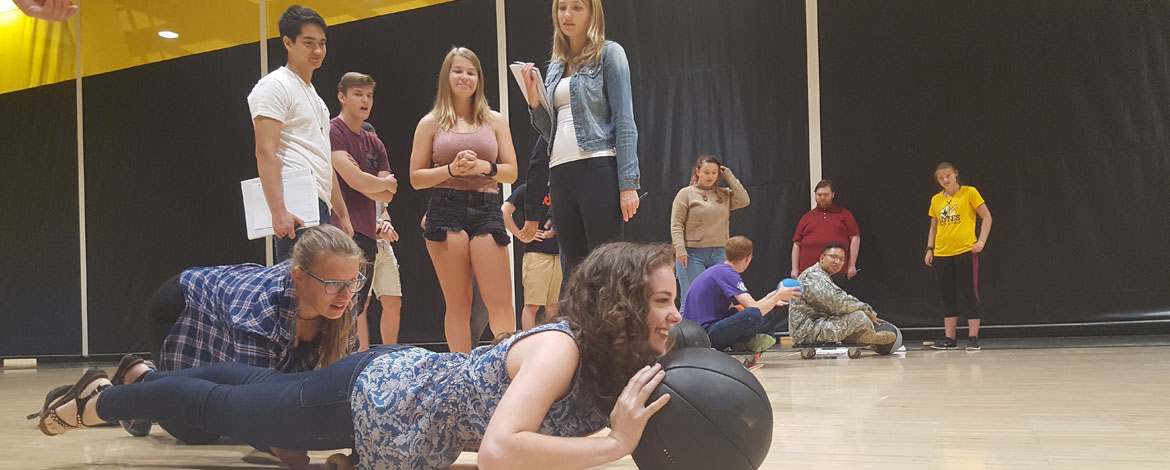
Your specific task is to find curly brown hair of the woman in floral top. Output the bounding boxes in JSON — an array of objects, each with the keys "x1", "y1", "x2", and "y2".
[{"x1": 557, "y1": 242, "x2": 674, "y2": 413}]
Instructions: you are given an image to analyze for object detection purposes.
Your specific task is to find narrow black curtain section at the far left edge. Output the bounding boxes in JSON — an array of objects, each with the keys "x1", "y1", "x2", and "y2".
[{"x1": 0, "y1": 81, "x2": 81, "y2": 357}]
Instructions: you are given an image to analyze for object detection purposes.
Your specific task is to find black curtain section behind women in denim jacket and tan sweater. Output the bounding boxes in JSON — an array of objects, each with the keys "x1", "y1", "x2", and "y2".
[{"x1": 507, "y1": 0, "x2": 808, "y2": 296}]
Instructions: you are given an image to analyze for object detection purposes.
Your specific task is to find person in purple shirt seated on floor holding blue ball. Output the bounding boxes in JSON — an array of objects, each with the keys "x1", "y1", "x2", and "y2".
[{"x1": 682, "y1": 236, "x2": 800, "y2": 352}]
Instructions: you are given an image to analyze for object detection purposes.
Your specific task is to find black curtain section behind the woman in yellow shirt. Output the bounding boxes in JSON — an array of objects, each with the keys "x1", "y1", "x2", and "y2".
[{"x1": 819, "y1": 0, "x2": 1170, "y2": 326}]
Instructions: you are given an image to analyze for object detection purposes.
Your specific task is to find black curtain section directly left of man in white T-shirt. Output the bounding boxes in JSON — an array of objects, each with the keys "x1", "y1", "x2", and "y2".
[{"x1": 83, "y1": 44, "x2": 264, "y2": 354}]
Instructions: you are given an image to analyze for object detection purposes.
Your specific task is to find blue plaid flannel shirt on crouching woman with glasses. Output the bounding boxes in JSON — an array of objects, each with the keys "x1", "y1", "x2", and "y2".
[{"x1": 159, "y1": 262, "x2": 357, "y2": 372}]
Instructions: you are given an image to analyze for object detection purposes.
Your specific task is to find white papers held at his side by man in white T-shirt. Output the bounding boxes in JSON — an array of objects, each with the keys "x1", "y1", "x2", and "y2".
[{"x1": 240, "y1": 168, "x2": 321, "y2": 240}]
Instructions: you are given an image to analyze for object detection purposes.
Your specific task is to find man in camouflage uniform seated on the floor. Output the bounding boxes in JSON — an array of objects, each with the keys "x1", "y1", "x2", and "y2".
[{"x1": 789, "y1": 243, "x2": 896, "y2": 345}]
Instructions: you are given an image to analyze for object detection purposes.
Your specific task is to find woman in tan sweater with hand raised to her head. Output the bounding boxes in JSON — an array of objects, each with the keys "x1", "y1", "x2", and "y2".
[{"x1": 670, "y1": 155, "x2": 751, "y2": 302}]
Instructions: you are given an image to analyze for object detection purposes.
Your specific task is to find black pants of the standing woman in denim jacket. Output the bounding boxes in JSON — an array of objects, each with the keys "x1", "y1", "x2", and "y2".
[{"x1": 549, "y1": 157, "x2": 624, "y2": 280}]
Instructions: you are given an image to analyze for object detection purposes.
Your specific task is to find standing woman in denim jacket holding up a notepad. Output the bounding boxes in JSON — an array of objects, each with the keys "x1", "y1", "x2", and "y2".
[{"x1": 522, "y1": 0, "x2": 640, "y2": 276}]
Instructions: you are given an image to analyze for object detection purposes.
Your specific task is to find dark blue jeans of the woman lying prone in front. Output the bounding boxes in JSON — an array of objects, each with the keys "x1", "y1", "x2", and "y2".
[{"x1": 97, "y1": 345, "x2": 408, "y2": 450}]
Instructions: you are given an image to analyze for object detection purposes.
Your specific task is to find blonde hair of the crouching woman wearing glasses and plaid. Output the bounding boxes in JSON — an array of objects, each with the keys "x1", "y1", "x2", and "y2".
[{"x1": 289, "y1": 224, "x2": 366, "y2": 368}]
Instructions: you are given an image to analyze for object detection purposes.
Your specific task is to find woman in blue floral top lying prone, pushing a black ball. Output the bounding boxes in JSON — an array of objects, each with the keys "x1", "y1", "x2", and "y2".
[{"x1": 41, "y1": 243, "x2": 681, "y2": 469}]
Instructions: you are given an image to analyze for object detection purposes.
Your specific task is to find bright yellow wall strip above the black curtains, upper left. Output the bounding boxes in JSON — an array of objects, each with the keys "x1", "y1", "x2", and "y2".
[{"x1": 0, "y1": 0, "x2": 453, "y2": 94}]
